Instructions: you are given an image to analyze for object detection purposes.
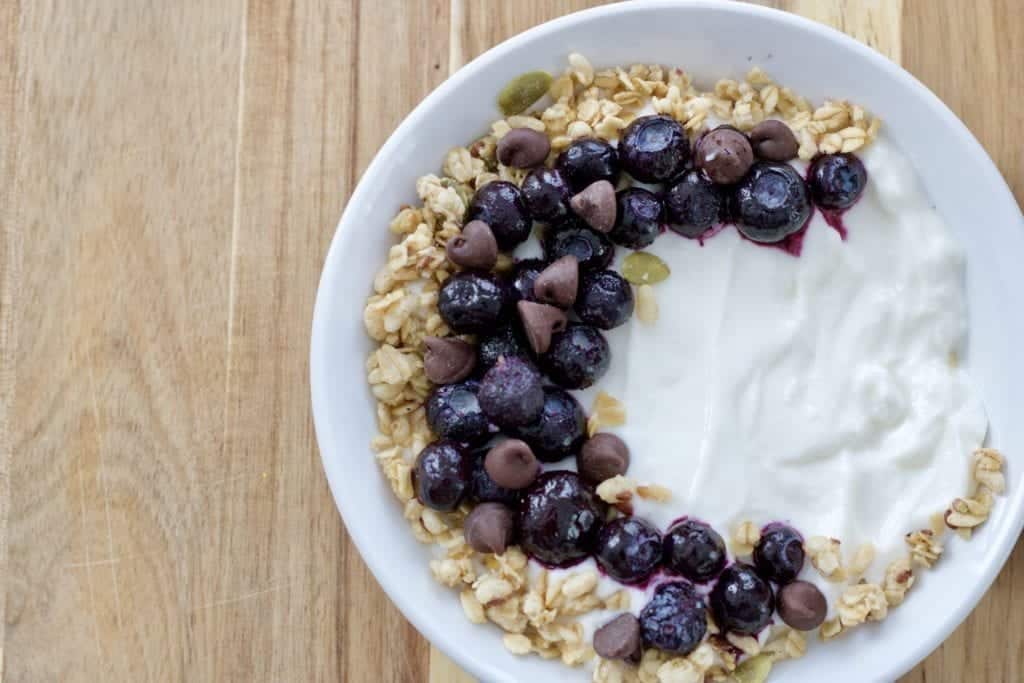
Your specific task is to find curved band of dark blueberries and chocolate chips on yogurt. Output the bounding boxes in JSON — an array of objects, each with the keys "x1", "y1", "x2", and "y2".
[{"x1": 414, "y1": 116, "x2": 866, "y2": 658}]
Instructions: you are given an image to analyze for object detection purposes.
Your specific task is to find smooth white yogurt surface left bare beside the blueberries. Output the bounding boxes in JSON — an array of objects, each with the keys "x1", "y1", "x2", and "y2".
[{"x1": 580, "y1": 140, "x2": 987, "y2": 593}]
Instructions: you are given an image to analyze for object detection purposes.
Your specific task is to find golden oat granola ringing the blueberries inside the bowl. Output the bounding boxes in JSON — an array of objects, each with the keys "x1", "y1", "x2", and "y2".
[{"x1": 364, "y1": 54, "x2": 1006, "y2": 683}]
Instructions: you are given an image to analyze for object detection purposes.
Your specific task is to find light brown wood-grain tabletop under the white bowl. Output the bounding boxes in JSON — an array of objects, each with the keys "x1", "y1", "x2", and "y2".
[{"x1": 0, "y1": 0, "x2": 1024, "y2": 683}]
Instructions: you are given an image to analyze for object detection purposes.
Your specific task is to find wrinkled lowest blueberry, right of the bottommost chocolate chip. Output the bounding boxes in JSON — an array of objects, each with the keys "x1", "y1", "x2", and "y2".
[{"x1": 640, "y1": 581, "x2": 708, "y2": 654}]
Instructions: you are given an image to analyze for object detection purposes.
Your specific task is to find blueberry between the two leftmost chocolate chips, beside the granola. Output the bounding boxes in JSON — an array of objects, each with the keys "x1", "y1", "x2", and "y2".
[{"x1": 437, "y1": 270, "x2": 513, "y2": 334}]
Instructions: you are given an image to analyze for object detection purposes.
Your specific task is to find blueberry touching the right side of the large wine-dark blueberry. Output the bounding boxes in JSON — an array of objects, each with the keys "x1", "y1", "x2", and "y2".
[{"x1": 594, "y1": 517, "x2": 662, "y2": 584}]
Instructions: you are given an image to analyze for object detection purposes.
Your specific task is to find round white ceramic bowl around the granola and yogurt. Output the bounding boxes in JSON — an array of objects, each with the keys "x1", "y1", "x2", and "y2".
[{"x1": 310, "y1": 1, "x2": 1024, "y2": 683}]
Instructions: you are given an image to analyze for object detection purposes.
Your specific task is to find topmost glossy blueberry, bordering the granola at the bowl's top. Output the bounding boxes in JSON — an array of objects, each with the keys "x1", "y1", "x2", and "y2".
[{"x1": 618, "y1": 114, "x2": 690, "y2": 182}]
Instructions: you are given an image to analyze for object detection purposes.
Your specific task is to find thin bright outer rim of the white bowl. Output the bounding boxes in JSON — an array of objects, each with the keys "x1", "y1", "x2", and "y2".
[{"x1": 309, "y1": 0, "x2": 1024, "y2": 680}]
